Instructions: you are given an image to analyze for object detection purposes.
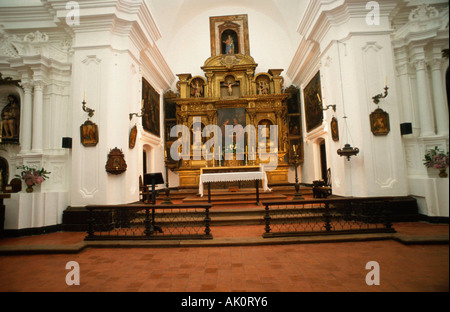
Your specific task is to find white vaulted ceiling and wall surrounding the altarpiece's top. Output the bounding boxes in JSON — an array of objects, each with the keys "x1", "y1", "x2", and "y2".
[{"x1": 146, "y1": 0, "x2": 309, "y2": 80}]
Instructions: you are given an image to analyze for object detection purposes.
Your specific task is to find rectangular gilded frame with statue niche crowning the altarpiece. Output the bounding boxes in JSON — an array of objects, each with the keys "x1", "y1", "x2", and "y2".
[{"x1": 209, "y1": 14, "x2": 250, "y2": 56}]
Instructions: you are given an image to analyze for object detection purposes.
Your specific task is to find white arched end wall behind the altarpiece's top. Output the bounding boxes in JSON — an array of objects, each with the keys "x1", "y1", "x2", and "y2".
[{"x1": 158, "y1": 3, "x2": 297, "y2": 83}]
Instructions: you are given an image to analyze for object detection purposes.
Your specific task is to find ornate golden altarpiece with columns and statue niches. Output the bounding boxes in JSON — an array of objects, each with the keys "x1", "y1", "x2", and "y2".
[{"x1": 165, "y1": 15, "x2": 301, "y2": 188}]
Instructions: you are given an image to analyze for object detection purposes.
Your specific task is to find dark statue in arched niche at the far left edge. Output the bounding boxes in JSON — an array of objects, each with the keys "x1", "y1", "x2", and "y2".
[{"x1": 1, "y1": 94, "x2": 20, "y2": 141}]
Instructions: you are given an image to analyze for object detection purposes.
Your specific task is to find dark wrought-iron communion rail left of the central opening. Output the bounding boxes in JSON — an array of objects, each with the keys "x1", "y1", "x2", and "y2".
[{"x1": 85, "y1": 203, "x2": 212, "y2": 240}]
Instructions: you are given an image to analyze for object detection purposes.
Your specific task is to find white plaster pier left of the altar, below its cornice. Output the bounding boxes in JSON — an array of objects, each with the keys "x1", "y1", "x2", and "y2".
[{"x1": 71, "y1": 48, "x2": 142, "y2": 206}]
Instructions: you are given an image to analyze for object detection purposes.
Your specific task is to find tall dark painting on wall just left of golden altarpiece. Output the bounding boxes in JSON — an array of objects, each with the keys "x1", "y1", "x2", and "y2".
[{"x1": 142, "y1": 78, "x2": 161, "y2": 137}]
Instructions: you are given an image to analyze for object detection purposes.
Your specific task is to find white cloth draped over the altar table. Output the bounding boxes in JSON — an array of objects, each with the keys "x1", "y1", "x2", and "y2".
[{"x1": 198, "y1": 168, "x2": 270, "y2": 197}]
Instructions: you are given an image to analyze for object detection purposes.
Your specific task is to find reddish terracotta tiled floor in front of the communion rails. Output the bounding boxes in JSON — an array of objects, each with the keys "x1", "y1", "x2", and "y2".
[{"x1": 0, "y1": 223, "x2": 449, "y2": 292}]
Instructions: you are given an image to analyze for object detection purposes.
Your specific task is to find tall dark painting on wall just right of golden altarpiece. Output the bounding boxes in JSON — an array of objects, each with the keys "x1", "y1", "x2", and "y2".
[{"x1": 303, "y1": 71, "x2": 323, "y2": 132}]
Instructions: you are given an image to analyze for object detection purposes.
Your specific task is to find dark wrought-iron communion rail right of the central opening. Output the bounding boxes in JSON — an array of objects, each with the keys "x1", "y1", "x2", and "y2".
[{"x1": 262, "y1": 197, "x2": 395, "y2": 238}]
